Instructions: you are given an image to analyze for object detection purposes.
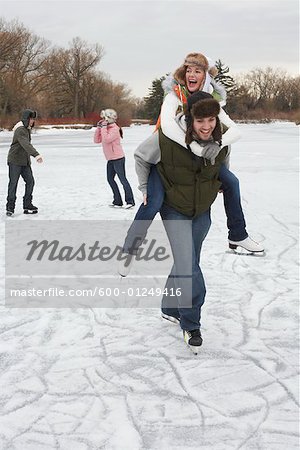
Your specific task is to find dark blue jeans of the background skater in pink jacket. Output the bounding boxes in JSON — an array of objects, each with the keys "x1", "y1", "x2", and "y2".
[{"x1": 106, "y1": 157, "x2": 134, "y2": 206}]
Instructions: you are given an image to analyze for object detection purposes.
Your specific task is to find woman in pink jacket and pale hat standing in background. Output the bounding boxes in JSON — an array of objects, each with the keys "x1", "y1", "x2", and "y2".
[{"x1": 94, "y1": 109, "x2": 135, "y2": 209}]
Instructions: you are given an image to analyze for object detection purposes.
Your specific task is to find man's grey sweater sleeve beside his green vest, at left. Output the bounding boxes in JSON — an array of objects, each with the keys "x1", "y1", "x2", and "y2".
[{"x1": 134, "y1": 131, "x2": 161, "y2": 194}]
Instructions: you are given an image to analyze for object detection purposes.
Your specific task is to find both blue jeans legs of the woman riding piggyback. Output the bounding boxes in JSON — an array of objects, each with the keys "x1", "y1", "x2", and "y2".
[{"x1": 123, "y1": 164, "x2": 248, "y2": 255}]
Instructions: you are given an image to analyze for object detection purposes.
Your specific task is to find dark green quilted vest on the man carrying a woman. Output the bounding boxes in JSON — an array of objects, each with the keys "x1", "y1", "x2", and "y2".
[{"x1": 157, "y1": 130, "x2": 227, "y2": 217}]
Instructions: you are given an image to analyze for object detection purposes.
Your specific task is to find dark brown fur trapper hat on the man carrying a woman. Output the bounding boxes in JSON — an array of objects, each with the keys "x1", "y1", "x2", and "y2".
[{"x1": 185, "y1": 91, "x2": 222, "y2": 144}]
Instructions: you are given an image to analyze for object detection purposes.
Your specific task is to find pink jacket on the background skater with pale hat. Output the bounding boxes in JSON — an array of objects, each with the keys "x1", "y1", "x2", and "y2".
[{"x1": 94, "y1": 123, "x2": 125, "y2": 161}]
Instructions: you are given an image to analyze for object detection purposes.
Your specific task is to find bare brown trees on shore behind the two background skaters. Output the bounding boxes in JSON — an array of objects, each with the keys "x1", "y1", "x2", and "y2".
[{"x1": 0, "y1": 19, "x2": 137, "y2": 126}]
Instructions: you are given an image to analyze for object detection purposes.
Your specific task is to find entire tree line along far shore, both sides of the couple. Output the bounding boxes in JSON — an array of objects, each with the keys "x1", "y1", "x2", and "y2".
[{"x1": 0, "y1": 18, "x2": 300, "y2": 126}]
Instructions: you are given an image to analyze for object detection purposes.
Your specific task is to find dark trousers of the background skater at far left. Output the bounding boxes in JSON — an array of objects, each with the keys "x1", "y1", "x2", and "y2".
[{"x1": 6, "y1": 163, "x2": 34, "y2": 212}]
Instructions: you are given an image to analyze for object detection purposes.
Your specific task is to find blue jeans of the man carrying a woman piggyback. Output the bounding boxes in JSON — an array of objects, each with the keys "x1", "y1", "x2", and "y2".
[{"x1": 160, "y1": 204, "x2": 211, "y2": 330}]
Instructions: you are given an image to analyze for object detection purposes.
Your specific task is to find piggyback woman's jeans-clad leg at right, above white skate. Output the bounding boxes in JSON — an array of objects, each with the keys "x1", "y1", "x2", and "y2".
[{"x1": 219, "y1": 164, "x2": 248, "y2": 241}]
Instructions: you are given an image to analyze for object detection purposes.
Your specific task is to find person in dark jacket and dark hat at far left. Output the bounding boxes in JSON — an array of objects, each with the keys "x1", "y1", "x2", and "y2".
[{"x1": 6, "y1": 109, "x2": 43, "y2": 216}]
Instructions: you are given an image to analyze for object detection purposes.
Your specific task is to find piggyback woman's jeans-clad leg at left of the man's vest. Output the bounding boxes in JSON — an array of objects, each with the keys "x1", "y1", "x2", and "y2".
[{"x1": 123, "y1": 166, "x2": 165, "y2": 255}]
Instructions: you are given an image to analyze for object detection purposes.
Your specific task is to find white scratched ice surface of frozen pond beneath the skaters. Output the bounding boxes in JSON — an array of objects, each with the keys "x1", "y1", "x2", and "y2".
[{"x1": 0, "y1": 123, "x2": 299, "y2": 450}]
